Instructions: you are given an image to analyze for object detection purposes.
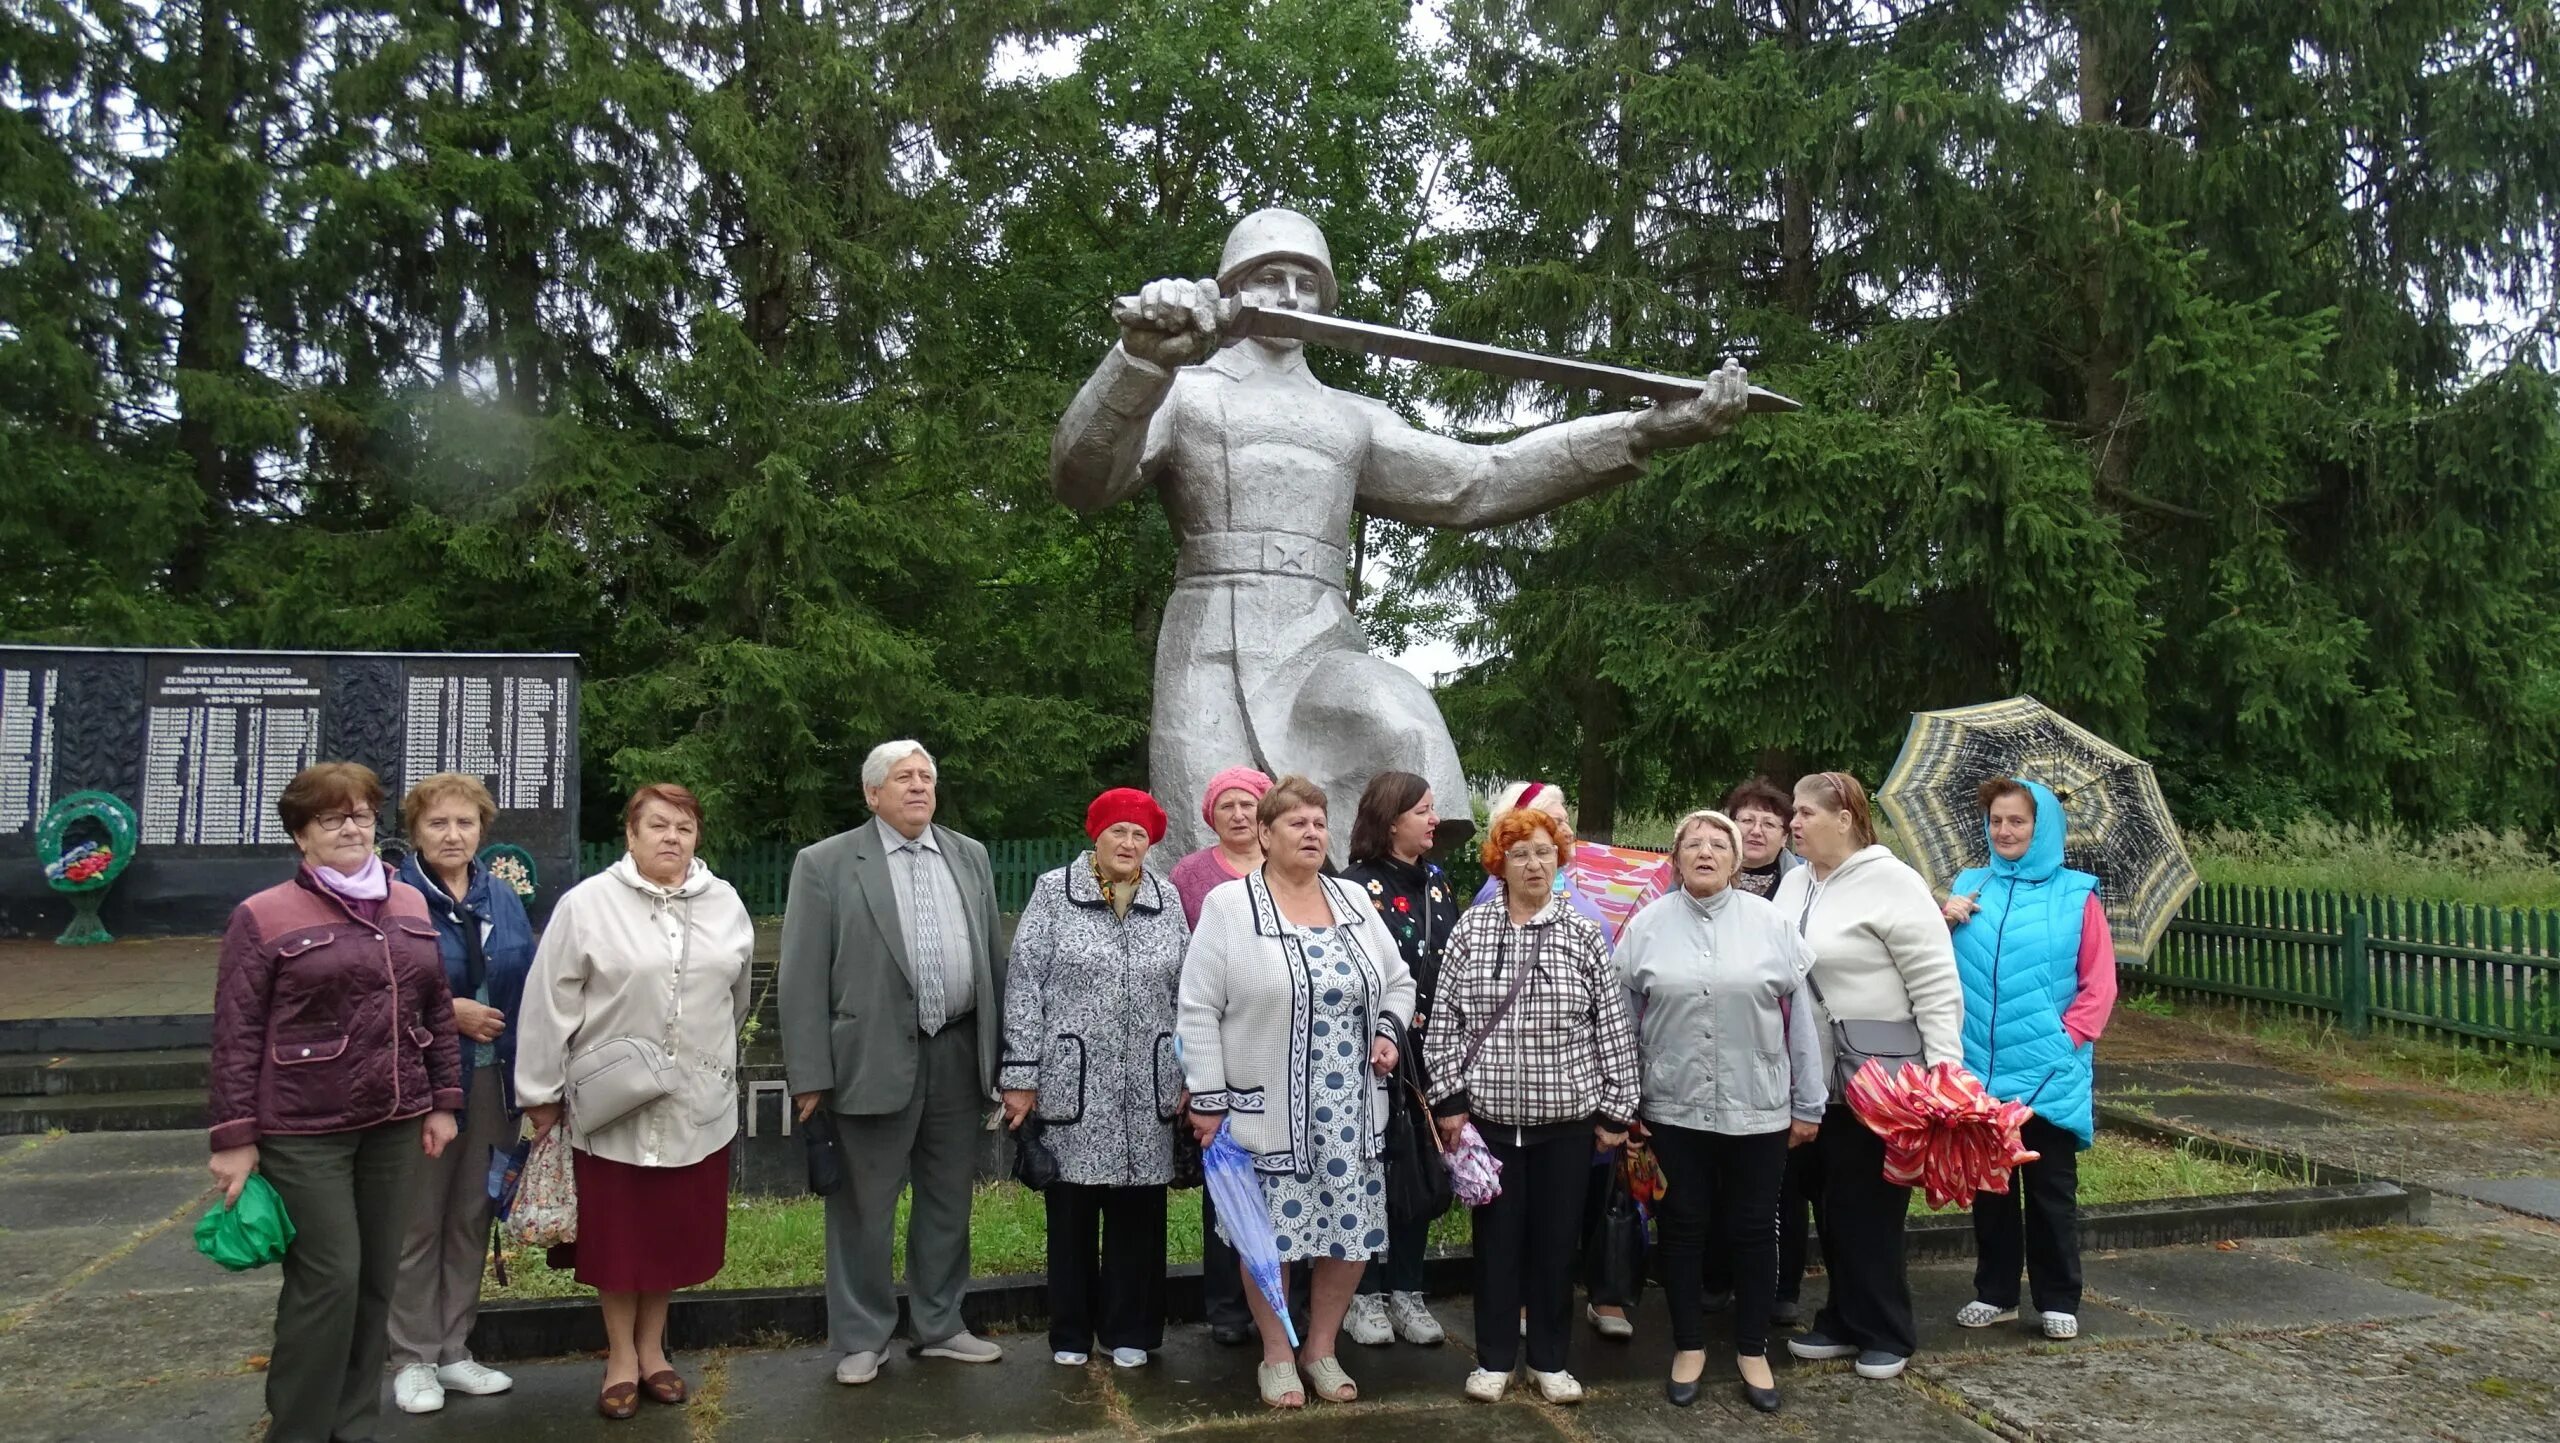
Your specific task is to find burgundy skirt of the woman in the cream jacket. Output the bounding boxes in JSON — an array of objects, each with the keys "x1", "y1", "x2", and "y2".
[{"x1": 548, "y1": 1146, "x2": 730, "y2": 1292}]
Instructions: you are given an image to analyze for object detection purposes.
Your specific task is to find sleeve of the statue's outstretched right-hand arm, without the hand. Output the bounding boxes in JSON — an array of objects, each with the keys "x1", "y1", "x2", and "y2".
[{"x1": 1359, "y1": 402, "x2": 1644, "y2": 532}]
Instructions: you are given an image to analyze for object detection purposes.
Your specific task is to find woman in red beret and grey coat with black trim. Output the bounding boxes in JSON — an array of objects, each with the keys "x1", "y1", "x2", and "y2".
[{"x1": 996, "y1": 785, "x2": 1190, "y2": 1369}]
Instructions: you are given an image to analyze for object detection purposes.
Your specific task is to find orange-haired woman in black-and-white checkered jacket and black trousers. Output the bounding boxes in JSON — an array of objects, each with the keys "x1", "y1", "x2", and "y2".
[{"x1": 1423, "y1": 806, "x2": 1638, "y2": 1402}]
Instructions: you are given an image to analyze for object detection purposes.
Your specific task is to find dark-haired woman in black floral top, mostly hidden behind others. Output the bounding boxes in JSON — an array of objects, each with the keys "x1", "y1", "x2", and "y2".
[{"x1": 1341, "y1": 773, "x2": 1459, "y2": 1348}]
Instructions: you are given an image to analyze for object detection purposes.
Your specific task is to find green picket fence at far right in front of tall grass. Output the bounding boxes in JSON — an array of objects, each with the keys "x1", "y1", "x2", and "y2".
[{"x1": 2140, "y1": 885, "x2": 2560, "y2": 1052}]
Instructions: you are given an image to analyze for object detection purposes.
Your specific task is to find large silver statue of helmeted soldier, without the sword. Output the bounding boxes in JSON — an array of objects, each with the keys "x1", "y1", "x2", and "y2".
[{"x1": 1050, "y1": 210, "x2": 1751, "y2": 860}]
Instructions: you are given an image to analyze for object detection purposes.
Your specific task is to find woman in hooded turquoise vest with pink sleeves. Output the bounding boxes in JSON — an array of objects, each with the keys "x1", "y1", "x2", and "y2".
[{"x1": 1946, "y1": 778, "x2": 2115, "y2": 1338}]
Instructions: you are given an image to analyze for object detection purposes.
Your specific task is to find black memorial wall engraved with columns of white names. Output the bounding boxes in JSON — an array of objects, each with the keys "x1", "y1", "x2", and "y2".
[{"x1": 0, "y1": 645, "x2": 579, "y2": 936}]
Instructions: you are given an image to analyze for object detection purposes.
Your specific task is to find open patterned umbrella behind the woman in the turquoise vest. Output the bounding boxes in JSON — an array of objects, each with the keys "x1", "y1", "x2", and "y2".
[{"x1": 1876, "y1": 696, "x2": 2196, "y2": 962}]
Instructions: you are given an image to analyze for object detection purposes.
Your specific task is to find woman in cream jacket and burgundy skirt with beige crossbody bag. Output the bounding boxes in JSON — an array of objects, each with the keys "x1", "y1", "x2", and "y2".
[{"x1": 515, "y1": 785, "x2": 755, "y2": 1417}]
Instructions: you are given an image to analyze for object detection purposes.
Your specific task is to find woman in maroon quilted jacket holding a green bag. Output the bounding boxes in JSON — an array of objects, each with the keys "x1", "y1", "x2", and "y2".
[{"x1": 207, "y1": 762, "x2": 463, "y2": 1443}]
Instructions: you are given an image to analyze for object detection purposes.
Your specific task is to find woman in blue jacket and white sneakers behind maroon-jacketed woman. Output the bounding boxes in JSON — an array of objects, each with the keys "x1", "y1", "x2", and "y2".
[{"x1": 392, "y1": 773, "x2": 532, "y2": 1412}]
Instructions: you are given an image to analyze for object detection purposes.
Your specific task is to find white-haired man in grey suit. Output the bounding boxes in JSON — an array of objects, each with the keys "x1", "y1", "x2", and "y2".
[{"x1": 778, "y1": 742, "x2": 1004, "y2": 1384}]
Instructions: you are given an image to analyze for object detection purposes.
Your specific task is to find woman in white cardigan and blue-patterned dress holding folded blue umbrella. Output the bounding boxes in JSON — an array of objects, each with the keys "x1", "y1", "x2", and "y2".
[{"x1": 1175, "y1": 778, "x2": 1413, "y2": 1407}]
